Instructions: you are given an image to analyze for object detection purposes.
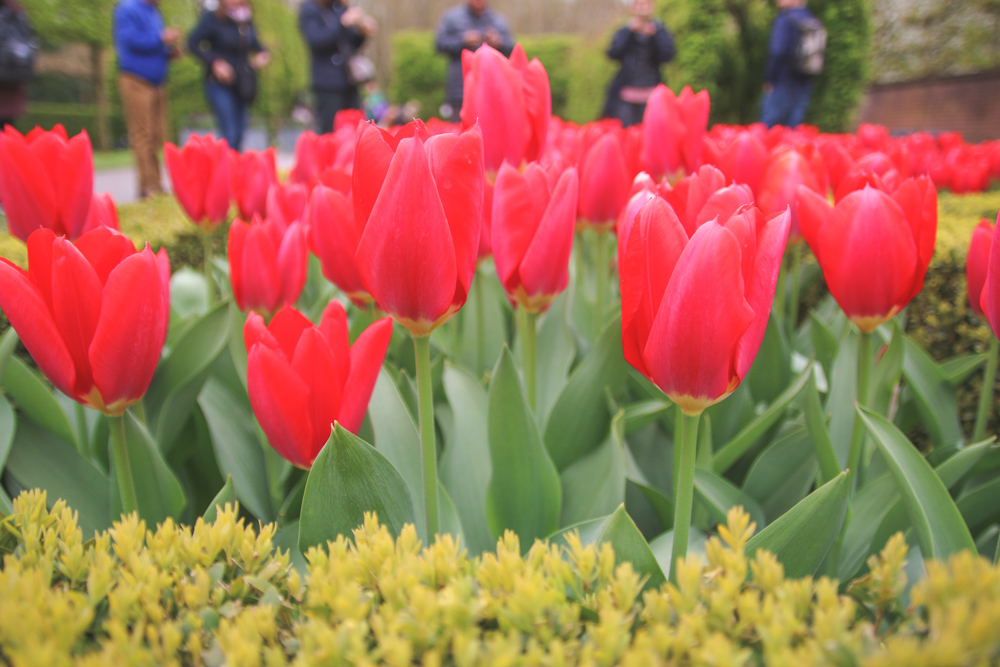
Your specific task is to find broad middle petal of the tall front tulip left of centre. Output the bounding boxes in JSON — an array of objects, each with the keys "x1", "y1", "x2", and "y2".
[{"x1": 357, "y1": 139, "x2": 458, "y2": 332}]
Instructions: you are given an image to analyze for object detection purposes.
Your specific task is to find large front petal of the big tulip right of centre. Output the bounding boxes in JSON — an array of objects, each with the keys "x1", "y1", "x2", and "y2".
[{"x1": 643, "y1": 223, "x2": 754, "y2": 413}]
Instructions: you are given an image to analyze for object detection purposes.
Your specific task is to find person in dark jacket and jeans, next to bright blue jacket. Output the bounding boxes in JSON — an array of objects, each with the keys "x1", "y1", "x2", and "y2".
[{"x1": 188, "y1": 0, "x2": 271, "y2": 151}]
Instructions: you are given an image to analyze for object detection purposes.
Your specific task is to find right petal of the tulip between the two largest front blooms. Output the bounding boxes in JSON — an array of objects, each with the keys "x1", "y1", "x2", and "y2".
[{"x1": 519, "y1": 168, "x2": 579, "y2": 296}]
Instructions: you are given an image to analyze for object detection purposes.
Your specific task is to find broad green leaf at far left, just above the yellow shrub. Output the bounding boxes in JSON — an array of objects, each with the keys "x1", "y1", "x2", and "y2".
[{"x1": 4, "y1": 420, "x2": 111, "y2": 539}]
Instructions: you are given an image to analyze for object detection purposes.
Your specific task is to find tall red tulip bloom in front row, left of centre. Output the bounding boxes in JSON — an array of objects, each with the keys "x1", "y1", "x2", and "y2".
[{"x1": 354, "y1": 126, "x2": 483, "y2": 336}]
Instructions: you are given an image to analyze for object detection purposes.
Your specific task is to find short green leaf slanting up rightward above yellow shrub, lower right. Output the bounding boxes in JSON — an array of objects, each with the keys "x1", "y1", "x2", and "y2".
[{"x1": 746, "y1": 473, "x2": 851, "y2": 579}]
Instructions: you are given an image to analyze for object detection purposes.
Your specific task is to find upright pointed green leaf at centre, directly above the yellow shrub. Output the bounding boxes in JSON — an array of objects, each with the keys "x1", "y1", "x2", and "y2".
[{"x1": 486, "y1": 348, "x2": 562, "y2": 549}]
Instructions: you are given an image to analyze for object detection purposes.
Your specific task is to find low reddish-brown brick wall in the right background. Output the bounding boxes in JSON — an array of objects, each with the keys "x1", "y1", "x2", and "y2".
[{"x1": 858, "y1": 70, "x2": 1000, "y2": 141}]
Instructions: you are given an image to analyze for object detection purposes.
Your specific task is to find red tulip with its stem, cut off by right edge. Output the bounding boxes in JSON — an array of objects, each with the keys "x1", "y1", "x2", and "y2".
[{"x1": 965, "y1": 218, "x2": 1000, "y2": 442}]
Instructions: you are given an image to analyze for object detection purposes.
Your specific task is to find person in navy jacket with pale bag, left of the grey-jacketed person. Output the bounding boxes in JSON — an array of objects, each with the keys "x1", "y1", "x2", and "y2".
[{"x1": 299, "y1": 0, "x2": 378, "y2": 133}]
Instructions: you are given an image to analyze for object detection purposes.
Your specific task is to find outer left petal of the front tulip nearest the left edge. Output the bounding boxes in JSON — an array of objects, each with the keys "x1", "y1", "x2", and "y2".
[{"x1": 0, "y1": 258, "x2": 76, "y2": 396}]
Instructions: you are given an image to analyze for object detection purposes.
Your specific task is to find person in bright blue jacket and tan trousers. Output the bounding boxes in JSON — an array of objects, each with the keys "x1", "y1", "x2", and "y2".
[{"x1": 112, "y1": 0, "x2": 181, "y2": 197}]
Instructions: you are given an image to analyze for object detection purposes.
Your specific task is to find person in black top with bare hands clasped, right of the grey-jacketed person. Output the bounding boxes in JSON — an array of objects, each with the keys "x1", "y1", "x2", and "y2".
[{"x1": 605, "y1": 0, "x2": 676, "y2": 127}]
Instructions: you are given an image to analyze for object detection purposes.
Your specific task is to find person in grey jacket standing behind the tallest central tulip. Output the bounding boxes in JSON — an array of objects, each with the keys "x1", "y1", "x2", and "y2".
[{"x1": 434, "y1": 0, "x2": 514, "y2": 123}]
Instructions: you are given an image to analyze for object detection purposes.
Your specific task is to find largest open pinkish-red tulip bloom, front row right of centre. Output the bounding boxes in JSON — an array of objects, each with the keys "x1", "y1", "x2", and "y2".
[{"x1": 620, "y1": 197, "x2": 790, "y2": 415}]
